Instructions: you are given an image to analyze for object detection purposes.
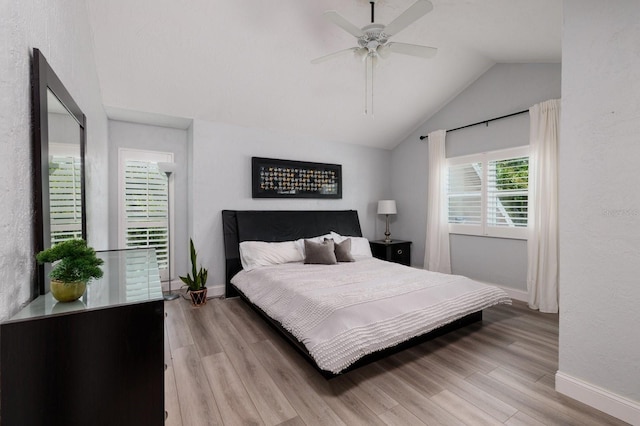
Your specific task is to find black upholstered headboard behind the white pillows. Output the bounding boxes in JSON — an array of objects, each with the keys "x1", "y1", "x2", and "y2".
[{"x1": 222, "y1": 210, "x2": 362, "y2": 297}]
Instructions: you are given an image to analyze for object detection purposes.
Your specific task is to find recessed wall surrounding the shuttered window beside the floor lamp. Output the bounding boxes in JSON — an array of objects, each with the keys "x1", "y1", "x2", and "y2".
[{"x1": 109, "y1": 120, "x2": 189, "y2": 279}]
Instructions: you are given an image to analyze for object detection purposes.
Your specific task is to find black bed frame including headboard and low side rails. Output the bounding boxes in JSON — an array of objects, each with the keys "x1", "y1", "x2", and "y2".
[{"x1": 222, "y1": 210, "x2": 482, "y2": 378}]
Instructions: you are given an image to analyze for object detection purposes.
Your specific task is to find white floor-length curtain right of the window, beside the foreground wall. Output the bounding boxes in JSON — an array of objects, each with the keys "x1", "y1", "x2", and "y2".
[{"x1": 527, "y1": 99, "x2": 560, "y2": 313}]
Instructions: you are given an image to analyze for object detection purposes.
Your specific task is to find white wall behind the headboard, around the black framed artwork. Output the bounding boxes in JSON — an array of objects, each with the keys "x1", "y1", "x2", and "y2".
[{"x1": 189, "y1": 120, "x2": 391, "y2": 287}]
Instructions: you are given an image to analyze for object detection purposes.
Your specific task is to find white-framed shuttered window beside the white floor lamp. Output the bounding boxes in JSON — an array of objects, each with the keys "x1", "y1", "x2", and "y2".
[{"x1": 118, "y1": 149, "x2": 173, "y2": 281}]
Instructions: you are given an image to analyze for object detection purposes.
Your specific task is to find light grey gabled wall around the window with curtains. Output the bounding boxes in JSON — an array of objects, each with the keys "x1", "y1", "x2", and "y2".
[{"x1": 391, "y1": 64, "x2": 561, "y2": 291}]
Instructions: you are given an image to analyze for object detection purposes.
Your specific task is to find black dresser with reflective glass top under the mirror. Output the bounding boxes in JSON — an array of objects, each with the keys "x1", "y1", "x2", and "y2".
[{"x1": 0, "y1": 249, "x2": 165, "y2": 426}]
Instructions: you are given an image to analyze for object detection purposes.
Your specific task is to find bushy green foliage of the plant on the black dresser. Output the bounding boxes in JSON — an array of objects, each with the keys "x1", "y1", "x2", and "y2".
[{"x1": 36, "y1": 239, "x2": 104, "y2": 283}]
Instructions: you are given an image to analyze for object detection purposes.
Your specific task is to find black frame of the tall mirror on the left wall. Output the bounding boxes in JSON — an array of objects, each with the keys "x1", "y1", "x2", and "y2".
[{"x1": 32, "y1": 48, "x2": 87, "y2": 295}]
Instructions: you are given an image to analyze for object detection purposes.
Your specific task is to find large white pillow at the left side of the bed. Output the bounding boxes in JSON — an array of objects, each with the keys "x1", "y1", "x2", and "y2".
[{"x1": 240, "y1": 241, "x2": 304, "y2": 271}]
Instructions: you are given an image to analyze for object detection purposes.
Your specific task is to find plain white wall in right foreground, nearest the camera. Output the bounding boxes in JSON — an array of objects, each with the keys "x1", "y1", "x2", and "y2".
[{"x1": 556, "y1": 0, "x2": 640, "y2": 424}]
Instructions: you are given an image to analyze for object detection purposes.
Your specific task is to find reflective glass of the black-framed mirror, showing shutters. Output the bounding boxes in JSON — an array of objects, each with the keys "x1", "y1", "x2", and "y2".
[{"x1": 47, "y1": 90, "x2": 82, "y2": 245}]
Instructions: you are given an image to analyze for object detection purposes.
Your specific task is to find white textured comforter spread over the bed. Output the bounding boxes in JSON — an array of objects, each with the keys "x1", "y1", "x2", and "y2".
[{"x1": 231, "y1": 258, "x2": 511, "y2": 373}]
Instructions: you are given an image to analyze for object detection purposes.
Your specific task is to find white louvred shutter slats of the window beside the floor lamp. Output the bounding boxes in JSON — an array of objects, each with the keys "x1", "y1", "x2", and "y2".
[{"x1": 124, "y1": 160, "x2": 169, "y2": 269}]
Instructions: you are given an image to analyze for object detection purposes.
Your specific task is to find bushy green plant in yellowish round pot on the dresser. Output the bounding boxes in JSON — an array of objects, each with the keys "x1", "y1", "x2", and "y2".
[{"x1": 36, "y1": 239, "x2": 104, "y2": 302}]
